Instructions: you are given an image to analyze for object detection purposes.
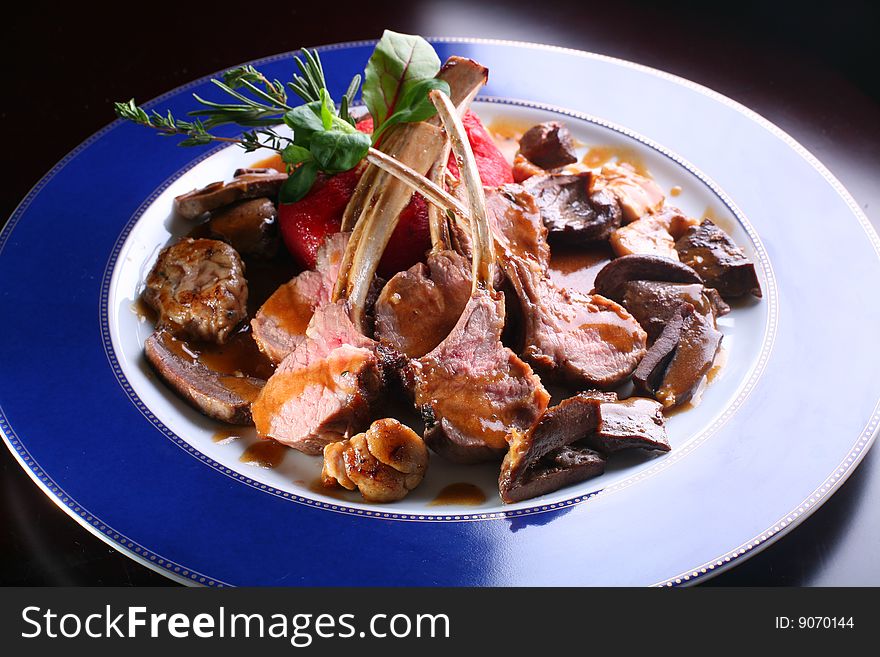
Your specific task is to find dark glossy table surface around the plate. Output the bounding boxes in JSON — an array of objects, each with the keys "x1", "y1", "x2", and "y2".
[{"x1": 0, "y1": 0, "x2": 880, "y2": 586}]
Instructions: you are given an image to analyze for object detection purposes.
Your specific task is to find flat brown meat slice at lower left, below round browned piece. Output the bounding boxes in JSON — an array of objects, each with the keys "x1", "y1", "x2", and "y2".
[{"x1": 144, "y1": 329, "x2": 266, "y2": 424}]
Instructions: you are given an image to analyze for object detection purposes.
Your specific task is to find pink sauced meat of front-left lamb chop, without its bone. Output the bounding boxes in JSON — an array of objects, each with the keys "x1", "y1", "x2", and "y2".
[{"x1": 252, "y1": 302, "x2": 385, "y2": 454}]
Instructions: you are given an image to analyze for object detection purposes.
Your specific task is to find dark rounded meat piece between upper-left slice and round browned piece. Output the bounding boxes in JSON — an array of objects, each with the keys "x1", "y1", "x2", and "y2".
[{"x1": 208, "y1": 198, "x2": 278, "y2": 258}]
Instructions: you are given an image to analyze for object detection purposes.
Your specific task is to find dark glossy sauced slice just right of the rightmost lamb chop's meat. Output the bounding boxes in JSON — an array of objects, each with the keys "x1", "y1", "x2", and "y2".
[{"x1": 633, "y1": 303, "x2": 723, "y2": 408}]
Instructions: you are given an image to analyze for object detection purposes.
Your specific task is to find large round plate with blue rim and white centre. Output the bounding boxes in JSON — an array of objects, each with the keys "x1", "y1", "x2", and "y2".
[{"x1": 0, "y1": 39, "x2": 880, "y2": 586}]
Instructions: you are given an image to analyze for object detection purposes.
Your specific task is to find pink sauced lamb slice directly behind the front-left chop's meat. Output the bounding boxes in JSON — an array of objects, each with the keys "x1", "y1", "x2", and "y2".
[{"x1": 251, "y1": 233, "x2": 349, "y2": 363}]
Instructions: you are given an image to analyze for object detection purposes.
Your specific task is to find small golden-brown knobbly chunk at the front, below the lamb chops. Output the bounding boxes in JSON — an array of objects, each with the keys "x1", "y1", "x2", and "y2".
[{"x1": 321, "y1": 418, "x2": 428, "y2": 502}]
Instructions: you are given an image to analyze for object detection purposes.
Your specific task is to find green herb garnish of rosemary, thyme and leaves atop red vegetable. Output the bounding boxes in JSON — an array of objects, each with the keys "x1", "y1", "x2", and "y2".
[{"x1": 114, "y1": 31, "x2": 449, "y2": 203}]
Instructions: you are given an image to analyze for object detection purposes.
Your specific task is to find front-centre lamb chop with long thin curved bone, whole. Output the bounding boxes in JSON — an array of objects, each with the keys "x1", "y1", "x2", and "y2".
[{"x1": 412, "y1": 91, "x2": 550, "y2": 463}]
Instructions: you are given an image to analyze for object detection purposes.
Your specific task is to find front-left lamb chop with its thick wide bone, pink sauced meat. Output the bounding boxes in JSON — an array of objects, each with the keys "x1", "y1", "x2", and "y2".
[{"x1": 252, "y1": 58, "x2": 486, "y2": 454}]
